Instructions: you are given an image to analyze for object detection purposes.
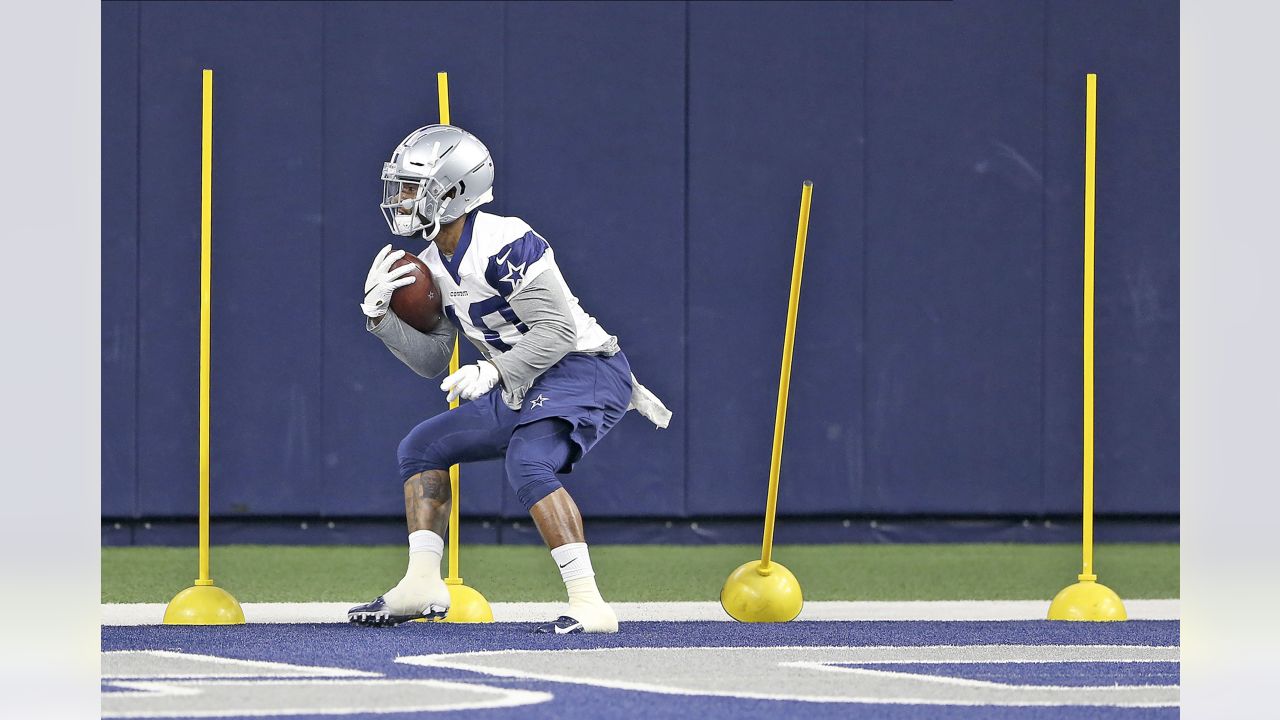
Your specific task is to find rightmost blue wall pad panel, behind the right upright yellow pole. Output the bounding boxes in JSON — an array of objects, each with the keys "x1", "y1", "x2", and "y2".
[{"x1": 1044, "y1": 1, "x2": 1179, "y2": 512}]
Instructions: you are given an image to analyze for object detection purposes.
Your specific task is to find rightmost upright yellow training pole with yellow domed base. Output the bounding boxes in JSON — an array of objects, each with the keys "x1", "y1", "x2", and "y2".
[{"x1": 1048, "y1": 73, "x2": 1129, "y2": 620}]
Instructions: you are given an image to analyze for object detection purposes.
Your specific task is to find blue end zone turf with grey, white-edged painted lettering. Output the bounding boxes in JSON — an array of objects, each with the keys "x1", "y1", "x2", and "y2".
[{"x1": 102, "y1": 621, "x2": 1179, "y2": 720}]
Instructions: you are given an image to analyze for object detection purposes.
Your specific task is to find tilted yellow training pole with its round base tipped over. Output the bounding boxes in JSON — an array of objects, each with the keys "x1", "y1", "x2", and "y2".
[{"x1": 721, "y1": 181, "x2": 813, "y2": 623}]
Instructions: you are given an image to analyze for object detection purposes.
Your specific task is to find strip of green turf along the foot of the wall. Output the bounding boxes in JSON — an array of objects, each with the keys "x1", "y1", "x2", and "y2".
[{"x1": 102, "y1": 544, "x2": 1178, "y2": 602}]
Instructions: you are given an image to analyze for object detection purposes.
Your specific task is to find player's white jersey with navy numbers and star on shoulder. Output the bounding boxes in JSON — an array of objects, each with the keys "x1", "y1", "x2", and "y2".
[{"x1": 421, "y1": 210, "x2": 613, "y2": 357}]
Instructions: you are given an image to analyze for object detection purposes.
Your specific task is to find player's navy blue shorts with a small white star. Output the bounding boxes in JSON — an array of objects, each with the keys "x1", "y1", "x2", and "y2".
[{"x1": 399, "y1": 351, "x2": 631, "y2": 480}]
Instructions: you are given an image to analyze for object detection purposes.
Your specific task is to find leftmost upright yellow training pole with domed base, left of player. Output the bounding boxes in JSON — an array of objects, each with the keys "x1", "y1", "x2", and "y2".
[{"x1": 164, "y1": 69, "x2": 244, "y2": 625}]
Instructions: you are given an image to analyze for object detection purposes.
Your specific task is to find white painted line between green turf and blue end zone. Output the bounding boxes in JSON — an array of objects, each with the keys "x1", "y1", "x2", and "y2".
[{"x1": 101, "y1": 600, "x2": 1180, "y2": 625}]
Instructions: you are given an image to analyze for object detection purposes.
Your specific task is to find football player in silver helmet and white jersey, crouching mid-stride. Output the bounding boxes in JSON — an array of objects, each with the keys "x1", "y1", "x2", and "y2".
[{"x1": 347, "y1": 126, "x2": 671, "y2": 633}]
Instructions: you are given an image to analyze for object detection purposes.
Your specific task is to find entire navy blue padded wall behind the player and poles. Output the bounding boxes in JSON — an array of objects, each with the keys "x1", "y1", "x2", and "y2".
[{"x1": 102, "y1": 0, "x2": 1178, "y2": 518}]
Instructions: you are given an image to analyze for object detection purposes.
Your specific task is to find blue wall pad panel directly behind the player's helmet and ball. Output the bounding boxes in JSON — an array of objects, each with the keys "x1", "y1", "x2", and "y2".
[{"x1": 317, "y1": 3, "x2": 507, "y2": 515}]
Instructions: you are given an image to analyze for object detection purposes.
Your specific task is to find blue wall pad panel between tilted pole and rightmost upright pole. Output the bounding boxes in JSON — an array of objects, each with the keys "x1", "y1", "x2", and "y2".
[{"x1": 864, "y1": 3, "x2": 1044, "y2": 512}]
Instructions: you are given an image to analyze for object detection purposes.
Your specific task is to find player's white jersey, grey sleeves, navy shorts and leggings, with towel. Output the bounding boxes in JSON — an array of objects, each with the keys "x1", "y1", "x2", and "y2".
[{"x1": 367, "y1": 210, "x2": 671, "y2": 507}]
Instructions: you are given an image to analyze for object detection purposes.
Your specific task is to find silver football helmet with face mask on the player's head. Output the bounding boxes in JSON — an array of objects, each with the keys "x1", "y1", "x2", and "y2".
[{"x1": 381, "y1": 126, "x2": 493, "y2": 241}]
